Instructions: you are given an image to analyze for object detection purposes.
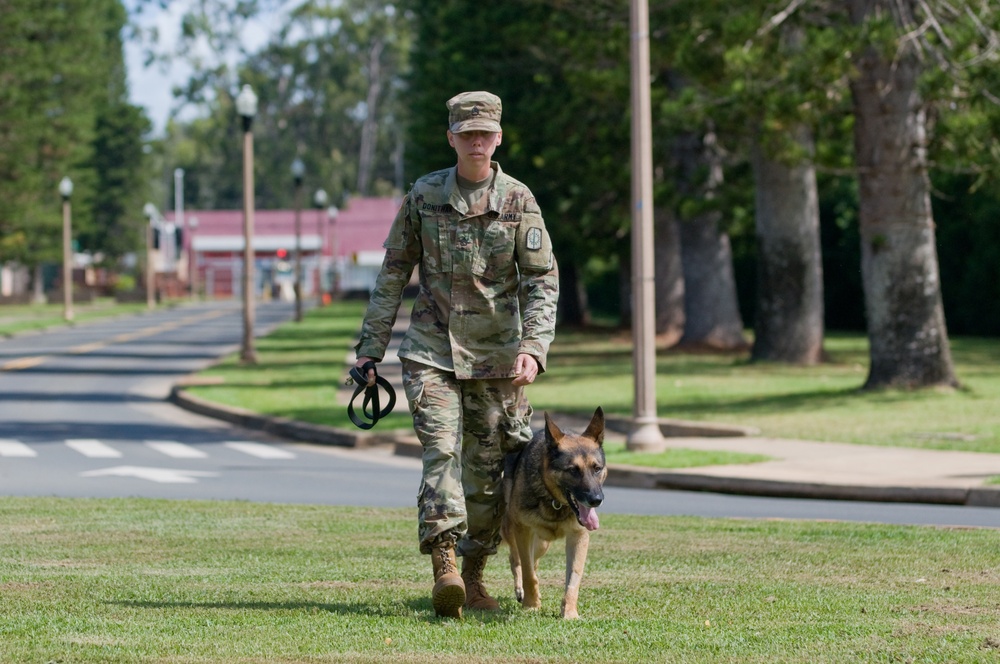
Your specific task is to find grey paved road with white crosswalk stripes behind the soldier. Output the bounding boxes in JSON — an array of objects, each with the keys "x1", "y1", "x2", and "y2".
[{"x1": 0, "y1": 303, "x2": 1000, "y2": 527}]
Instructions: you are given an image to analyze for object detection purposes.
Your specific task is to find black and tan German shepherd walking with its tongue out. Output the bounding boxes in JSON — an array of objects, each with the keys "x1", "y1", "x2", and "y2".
[{"x1": 501, "y1": 408, "x2": 608, "y2": 618}]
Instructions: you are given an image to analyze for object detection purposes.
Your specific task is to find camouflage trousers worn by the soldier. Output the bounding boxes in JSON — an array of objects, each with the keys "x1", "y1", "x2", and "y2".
[{"x1": 402, "y1": 359, "x2": 531, "y2": 557}]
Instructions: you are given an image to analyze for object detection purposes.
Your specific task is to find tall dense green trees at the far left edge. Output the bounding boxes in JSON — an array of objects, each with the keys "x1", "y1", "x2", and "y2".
[{"x1": 0, "y1": 0, "x2": 146, "y2": 282}]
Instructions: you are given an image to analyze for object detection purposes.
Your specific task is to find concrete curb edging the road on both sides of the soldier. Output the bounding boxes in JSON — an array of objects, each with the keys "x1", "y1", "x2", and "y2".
[{"x1": 169, "y1": 383, "x2": 1000, "y2": 507}]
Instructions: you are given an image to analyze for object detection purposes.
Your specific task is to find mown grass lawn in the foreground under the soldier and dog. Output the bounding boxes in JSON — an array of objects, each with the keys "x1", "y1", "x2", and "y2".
[{"x1": 0, "y1": 498, "x2": 1000, "y2": 664}]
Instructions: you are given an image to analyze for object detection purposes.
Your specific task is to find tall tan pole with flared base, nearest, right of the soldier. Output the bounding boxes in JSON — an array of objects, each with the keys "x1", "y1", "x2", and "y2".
[{"x1": 626, "y1": 0, "x2": 664, "y2": 452}]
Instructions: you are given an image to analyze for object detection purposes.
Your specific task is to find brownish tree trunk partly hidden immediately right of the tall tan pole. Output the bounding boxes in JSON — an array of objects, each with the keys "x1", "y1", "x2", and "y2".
[{"x1": 653, "y1": 208, "x2": 684, "y2": 346}]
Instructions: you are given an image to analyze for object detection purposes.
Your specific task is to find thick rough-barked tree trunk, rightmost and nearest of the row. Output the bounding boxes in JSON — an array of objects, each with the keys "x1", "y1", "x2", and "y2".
[{"x1": 851, "y1": 0, "x2": 958, "y2": 389}]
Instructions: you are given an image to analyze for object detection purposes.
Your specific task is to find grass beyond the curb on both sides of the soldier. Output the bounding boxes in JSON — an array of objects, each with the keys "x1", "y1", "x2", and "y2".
[{"x1": 186, "y1": 302, "x2": 1000, "y2": 456}]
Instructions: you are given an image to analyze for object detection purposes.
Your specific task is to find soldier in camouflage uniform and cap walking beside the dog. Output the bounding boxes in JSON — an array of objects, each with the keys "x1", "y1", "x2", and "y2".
[{"x1": 355, "y1": 92, "x2": 559, "y2": 618}]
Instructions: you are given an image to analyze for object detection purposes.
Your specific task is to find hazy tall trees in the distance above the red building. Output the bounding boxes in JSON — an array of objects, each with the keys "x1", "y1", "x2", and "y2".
[{"x1": 150, "y1": 0, "x2": 410, "y2": 208}]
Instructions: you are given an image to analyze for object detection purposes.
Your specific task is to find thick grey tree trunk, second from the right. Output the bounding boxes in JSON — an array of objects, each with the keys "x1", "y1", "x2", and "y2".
[{"x1": 751, "y1": 126, "x2": 823, "y2": 365}]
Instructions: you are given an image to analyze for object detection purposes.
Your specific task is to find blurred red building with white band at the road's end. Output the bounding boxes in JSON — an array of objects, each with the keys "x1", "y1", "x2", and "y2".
[{"x1": 160, "y1": 197, "x2": 400, "y2": 299}]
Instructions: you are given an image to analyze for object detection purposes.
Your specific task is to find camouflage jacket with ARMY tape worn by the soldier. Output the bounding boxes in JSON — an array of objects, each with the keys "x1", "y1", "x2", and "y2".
[{"x1": 355, "y1": 162, "x2": 559, "y2": 379}]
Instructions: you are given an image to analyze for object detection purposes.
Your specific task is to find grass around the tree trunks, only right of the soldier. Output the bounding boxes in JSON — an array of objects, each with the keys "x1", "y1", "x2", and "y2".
[{"x1": 532, "y1": 331, "x2": 1000, "y2": 453}]
